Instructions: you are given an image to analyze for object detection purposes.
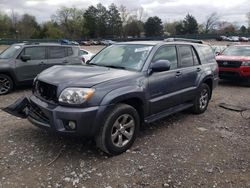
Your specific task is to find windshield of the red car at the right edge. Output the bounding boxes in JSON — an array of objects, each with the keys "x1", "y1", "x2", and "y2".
[{"x1": 222, "y1": 46, "x2": 250, "y2": 56}]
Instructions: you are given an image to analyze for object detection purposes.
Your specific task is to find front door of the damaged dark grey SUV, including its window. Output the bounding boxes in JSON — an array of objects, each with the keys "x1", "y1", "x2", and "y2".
[{"x1": 148, "y1": 45, "x2": 180, "y2": 114}]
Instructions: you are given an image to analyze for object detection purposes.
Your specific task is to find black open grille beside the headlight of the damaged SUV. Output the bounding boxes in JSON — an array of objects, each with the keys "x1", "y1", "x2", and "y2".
[{"x1": 35, "y1": 80, "x2": 57, "y2": 102}]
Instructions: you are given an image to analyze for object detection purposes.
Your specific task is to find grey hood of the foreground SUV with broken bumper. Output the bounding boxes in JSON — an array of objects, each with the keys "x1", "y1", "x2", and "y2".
[{"x1": 38, "y1": 66, "x2": 138, "y2": 87}]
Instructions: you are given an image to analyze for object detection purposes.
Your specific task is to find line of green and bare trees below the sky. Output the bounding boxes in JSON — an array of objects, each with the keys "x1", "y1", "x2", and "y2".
[{"x1": 0, "y1": 3, "x2": 250, "y2": 40}]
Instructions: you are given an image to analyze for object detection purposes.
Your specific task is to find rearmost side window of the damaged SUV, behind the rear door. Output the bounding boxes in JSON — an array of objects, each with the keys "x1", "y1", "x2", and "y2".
[{"x1": 196, "y1": 46, "x2": 215, "y2": 64}]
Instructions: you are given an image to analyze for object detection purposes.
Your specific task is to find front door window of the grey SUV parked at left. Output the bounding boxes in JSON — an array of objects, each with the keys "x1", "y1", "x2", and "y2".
[{"x1": 23, "y1": 47, "x2": 46, "y2": 60}]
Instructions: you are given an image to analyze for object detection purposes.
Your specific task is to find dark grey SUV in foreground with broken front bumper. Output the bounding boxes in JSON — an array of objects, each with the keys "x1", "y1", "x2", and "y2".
[{"x1": 4, "y1": 41, "x2": 218, "y2": 155}]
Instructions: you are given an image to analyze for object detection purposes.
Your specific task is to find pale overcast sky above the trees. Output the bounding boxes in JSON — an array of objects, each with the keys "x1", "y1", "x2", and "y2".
[{"x1": 0, "y1": 0, "x2": 250, "y2": 25}]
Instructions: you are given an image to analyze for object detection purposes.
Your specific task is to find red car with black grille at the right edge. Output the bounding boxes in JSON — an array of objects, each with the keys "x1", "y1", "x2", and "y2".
[{"x1": 216, "y1": 45, "x2": 250, "y2": 82}]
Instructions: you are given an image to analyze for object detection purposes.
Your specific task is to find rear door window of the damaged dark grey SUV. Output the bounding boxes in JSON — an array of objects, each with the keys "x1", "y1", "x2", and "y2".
[{"x1": 178, "y1": 46, "x2": 194, "y2": 67}]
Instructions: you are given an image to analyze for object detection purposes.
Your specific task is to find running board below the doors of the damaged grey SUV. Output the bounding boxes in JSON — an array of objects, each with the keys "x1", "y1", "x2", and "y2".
[{"x1": 145, "y1": 103, "x2": 193, "y2": 123}]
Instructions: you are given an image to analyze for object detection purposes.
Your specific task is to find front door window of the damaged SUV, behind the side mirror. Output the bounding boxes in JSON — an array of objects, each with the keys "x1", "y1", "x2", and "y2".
[{"x1": 153, "y1": 46, "x2": 177, "y2": 69}]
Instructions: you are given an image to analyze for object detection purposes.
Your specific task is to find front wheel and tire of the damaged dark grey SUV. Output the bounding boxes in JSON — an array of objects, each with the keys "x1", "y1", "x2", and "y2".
[{"x1": 95, "y1": 104, "x2": 140, "y2": 155}]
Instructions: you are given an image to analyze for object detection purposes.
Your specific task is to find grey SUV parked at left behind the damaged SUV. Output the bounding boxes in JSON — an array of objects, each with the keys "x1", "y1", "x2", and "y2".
[{"x1": 0, "y1": 43, "x2": 82, "y2": 95}]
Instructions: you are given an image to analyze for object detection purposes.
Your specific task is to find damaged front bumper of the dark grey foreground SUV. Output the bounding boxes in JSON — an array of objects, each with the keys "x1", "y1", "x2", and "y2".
[{"x1": 27, "y1": 96, "x2": 107, "y2": 137}]
